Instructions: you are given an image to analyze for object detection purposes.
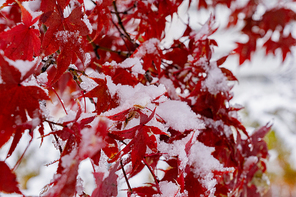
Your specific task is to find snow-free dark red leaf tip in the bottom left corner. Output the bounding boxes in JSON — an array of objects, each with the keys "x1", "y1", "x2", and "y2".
[{"x1": 0, "y1": 161, "x2": 22, "y2": 194}]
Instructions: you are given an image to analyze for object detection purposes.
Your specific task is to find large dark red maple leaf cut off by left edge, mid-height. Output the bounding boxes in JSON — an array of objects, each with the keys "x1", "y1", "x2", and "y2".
[{"x1": 0, "y1": 55, "x2": 49, "y2": 147}]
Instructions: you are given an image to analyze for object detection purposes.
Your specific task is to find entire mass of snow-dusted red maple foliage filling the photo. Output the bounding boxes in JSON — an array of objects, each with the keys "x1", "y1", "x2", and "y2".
[{"x1": 0, "y1": 0, "x2": 295, "y2": 196}]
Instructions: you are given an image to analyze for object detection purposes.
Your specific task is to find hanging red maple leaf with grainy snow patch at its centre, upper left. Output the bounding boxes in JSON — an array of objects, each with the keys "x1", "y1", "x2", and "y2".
[{"x1": 41, "y1": 7, "x2": 89, "y2": 84}]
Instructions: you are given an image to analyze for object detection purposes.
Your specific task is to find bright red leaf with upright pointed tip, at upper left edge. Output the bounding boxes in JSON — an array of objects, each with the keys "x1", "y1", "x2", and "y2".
[{"x1": 0, "y1": 4, "x2": 41, "y2": 61}]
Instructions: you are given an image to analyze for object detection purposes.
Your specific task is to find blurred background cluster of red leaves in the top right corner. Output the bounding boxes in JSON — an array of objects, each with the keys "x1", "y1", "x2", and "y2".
[{"x1": 198, "y1": 0, "x2": 296, "y2": 64}]
